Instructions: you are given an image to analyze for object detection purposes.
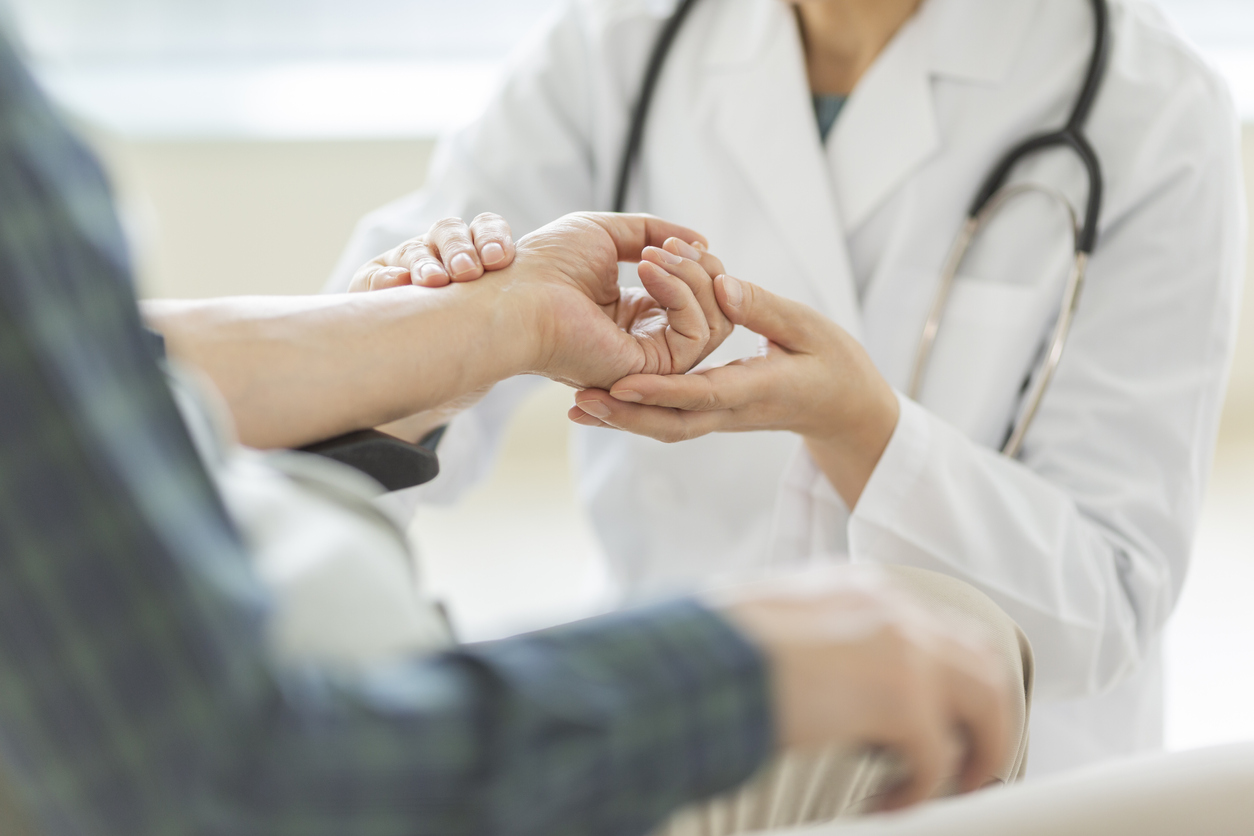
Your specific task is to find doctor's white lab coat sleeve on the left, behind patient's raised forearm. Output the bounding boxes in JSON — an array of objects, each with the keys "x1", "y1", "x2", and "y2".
[{"x1": 326, "y1": 0, "x2": 647, "y2": 514}]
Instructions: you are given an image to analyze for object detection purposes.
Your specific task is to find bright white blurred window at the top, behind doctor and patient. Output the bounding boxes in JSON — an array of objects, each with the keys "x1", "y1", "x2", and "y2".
[{"x1": 9, "y1": 0, "x2": 1254, "y2": 138}]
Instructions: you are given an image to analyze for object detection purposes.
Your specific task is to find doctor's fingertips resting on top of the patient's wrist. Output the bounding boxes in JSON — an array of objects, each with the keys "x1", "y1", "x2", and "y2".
[{"x1": 349, "y1": 212, "x2": 518, "y2": 293}]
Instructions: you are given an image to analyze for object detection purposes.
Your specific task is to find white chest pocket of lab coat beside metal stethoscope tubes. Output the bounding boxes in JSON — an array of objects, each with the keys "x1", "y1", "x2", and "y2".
[{"x1": 919, "y1": 277, "x2": 1056, "y2": 447}]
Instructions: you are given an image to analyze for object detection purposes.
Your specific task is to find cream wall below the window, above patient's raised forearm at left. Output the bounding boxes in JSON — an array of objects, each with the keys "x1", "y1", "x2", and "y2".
[{"x1": 94, "y1": 137, "x2": 433, "y2": 298}]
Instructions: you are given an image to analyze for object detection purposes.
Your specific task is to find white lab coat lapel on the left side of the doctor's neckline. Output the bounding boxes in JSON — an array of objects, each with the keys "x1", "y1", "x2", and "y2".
[{"x1": 709, "y1": 0, "x2": 861, "y2": 340}]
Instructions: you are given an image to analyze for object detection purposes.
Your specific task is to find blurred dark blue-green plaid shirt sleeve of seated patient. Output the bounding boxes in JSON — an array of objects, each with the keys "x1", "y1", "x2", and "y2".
[{"x1": 0, "y1": 36, "x2": 771, "y2": 836}]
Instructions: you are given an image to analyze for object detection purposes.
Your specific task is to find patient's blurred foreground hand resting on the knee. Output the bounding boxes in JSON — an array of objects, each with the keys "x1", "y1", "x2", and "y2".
[{"x1": 711, "y1": 568, "x2": 1014, "y2": 808}]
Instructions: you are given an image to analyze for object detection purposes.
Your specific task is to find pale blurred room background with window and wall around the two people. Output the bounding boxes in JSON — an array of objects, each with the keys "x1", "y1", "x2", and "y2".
[{"x1": 0, "y1": 0, "x2": 1254, "y2": 748}]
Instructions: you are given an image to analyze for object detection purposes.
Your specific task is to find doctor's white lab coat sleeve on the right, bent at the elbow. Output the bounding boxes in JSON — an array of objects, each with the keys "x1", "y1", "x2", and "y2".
[{"x1": 848, "y1": 58, "x2": 1245, "y2": 698}]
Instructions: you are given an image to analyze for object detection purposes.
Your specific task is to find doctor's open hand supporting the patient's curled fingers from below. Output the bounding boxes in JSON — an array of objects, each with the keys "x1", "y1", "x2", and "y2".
[{"x1": 569, "y1": 276, "x2": 900, "y2": 509}]
